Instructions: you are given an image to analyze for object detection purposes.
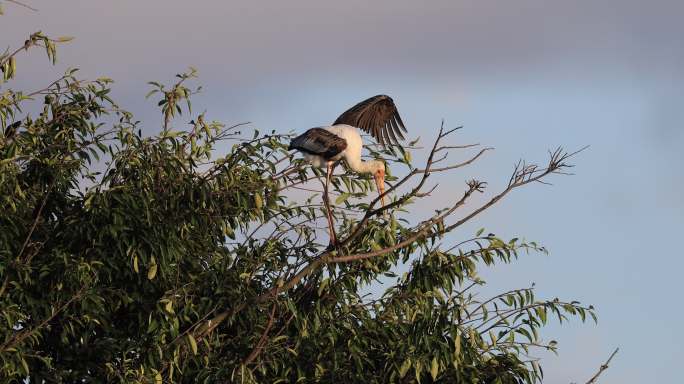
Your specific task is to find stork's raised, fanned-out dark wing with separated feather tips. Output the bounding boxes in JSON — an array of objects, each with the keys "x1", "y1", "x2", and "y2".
[{"x1": 333, "y1": 95, "x2": 406, "y2": 146}]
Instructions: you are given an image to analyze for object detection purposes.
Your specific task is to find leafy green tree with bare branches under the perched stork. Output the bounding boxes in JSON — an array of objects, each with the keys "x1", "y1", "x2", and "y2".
[{"x1": 0, "y1": 29, "x2": 595, "y2": 383}]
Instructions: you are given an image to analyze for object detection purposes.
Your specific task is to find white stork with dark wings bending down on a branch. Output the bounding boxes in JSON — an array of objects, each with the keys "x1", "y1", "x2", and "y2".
[{"x1": 288, "y1": 95, "x2": 407, "y2": 245}]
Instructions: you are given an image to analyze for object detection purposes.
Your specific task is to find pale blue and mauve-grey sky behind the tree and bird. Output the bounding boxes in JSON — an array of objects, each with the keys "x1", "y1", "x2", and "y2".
[{"x1": 0, "y1": 0, "x2": 684, "y2": 384}]
